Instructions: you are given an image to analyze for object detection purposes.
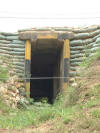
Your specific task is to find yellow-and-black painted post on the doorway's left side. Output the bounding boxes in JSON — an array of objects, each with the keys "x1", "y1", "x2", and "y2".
[{"x1": 25, "y1": 40, "x2": 31, "y2": 98}]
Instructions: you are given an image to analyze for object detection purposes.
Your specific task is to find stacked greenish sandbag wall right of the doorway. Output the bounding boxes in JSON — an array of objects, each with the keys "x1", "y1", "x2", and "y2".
[{"x1": 55, "y1": 25, "x2": 100, "y2": 77}]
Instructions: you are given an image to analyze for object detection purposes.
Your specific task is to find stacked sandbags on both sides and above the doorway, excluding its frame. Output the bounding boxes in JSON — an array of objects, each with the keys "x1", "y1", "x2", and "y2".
[{"x1": 0, "y1": 25, "x2": 100, "y2": 77}]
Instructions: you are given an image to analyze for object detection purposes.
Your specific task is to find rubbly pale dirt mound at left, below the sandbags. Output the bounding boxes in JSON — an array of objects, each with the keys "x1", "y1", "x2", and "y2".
[{"x1": 0, "y1": 58, "x2": 25, "y2": 108}]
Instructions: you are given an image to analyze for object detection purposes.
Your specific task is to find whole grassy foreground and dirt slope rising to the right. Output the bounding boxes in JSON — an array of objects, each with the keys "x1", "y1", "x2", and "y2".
[{"x1": 0, "y1": 51, "x2": 100, "y2": 133}]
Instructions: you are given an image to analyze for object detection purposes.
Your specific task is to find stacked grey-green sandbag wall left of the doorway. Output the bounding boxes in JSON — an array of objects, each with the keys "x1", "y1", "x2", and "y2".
[{"x1": 0, "y1": 32, "x2": 25, "y2": 77}]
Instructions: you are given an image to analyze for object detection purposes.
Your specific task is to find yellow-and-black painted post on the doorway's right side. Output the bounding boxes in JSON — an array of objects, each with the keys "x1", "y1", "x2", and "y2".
[{"x1": 63, "y1": 39, "x2": 70, "y2": 91}]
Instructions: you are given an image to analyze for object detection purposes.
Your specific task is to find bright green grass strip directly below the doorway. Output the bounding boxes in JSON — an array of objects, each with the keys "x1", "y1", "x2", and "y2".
[{"x1": 0, "y1": 89, "x2": 77, "y2": 129}]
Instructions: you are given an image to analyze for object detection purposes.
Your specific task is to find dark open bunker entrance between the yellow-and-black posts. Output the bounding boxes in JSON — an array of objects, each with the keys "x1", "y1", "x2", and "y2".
[{"x1": 30, "y1": 39, "x2": 63, "y2": 103}]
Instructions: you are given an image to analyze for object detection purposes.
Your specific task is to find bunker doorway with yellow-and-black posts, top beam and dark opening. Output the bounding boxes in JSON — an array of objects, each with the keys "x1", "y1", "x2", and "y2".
[{"x1": 19, "y1": 31, "x2": 73, "y2": 103}]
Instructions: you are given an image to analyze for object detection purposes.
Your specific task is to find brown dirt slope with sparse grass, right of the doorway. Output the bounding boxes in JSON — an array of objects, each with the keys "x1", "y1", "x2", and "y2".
[{"x1": 25, "y1": 59, "x2": 100, "y2": 133}]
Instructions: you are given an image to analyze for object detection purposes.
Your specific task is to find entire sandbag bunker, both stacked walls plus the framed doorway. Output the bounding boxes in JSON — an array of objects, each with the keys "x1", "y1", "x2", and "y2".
[{"x1": 0, "y1": 25, "x2": 100, "y2": 102}]
